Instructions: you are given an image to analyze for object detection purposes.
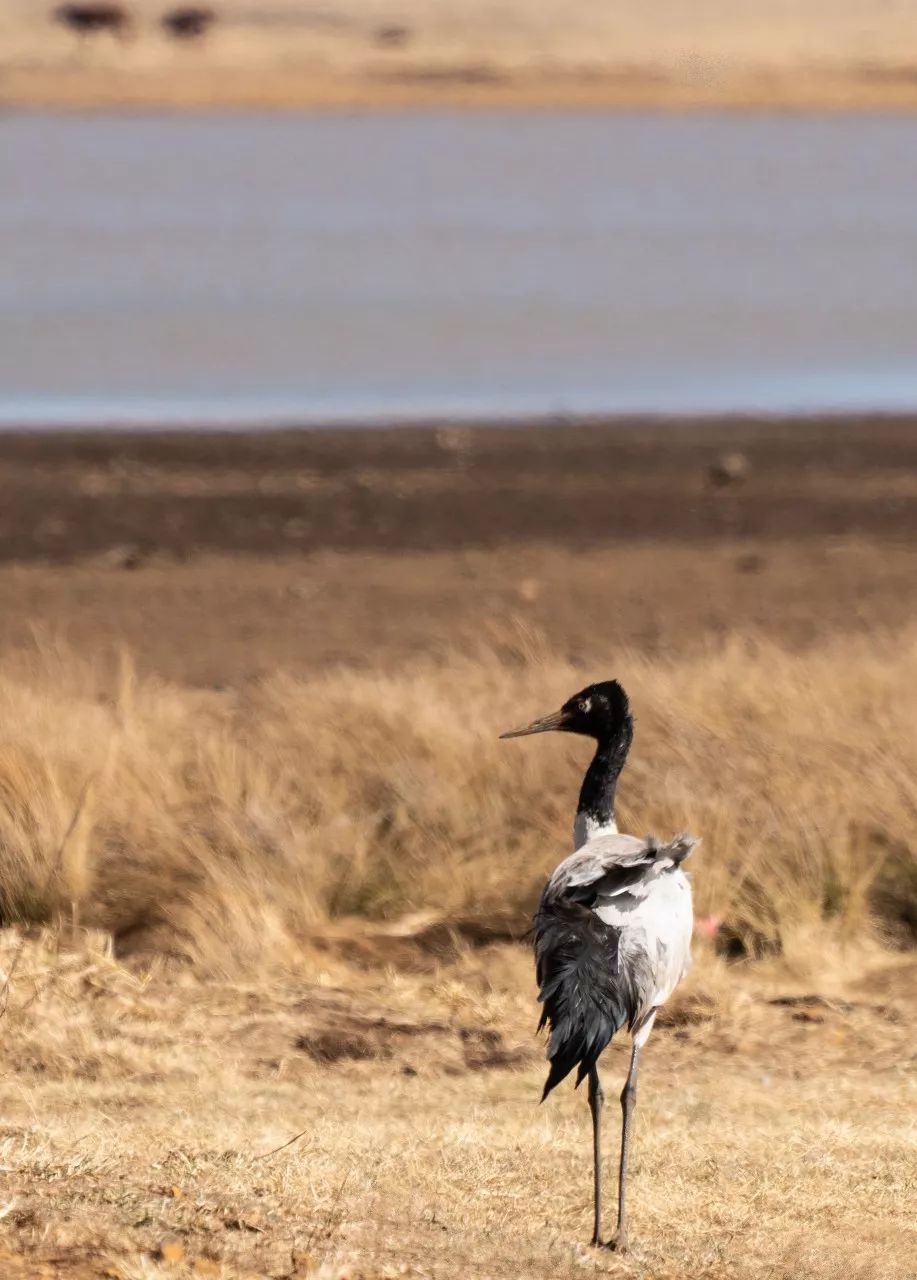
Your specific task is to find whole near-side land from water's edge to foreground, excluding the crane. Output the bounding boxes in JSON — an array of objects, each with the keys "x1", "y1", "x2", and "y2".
[{"x1": 0, "y1": 420, "x2": 917, "y2": 1280}]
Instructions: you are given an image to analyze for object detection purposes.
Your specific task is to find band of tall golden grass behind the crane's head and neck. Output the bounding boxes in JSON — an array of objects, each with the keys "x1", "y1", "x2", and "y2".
[{"x1": 0, "y1": 628, "x2": 917, "y2": 973}]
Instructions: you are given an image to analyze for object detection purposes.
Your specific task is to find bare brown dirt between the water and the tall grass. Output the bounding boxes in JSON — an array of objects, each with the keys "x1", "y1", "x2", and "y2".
[{"x1": 0, "y1": 419, "x2": 917, "y2": 685}]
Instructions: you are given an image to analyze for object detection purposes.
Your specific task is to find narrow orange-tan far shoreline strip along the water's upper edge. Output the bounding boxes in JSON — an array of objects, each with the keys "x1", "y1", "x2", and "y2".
[{"x1": 0, "y1": 65, "x2": 917, "y2": 115}]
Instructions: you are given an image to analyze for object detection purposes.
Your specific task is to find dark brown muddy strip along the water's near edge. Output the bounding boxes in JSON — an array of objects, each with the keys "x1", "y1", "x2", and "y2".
[{"x1": 0, "y1": 415, "x2": 917, "y2": 562}]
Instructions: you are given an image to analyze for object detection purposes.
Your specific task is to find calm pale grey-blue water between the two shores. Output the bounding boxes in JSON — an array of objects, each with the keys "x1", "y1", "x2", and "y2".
[{"x1": 0, "y1": 111, "x2": 917, "y2": 425}]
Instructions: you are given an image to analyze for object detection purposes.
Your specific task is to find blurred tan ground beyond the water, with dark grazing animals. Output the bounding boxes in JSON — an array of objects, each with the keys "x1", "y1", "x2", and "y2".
[{"x1": 0, "y1": 0, "x2": 917, "y2": 109}]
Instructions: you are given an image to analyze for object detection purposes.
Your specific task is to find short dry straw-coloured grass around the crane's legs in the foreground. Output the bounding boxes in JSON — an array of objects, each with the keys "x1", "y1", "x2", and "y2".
[{"x1": 0, "y1": 934, "x2": 917, "y2": 1280}]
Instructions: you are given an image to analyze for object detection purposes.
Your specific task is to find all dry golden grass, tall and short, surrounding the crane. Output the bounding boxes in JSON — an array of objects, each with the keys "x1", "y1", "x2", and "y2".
[{"x1": 0, "y1": 632, "x2": 917, "y2": 1280}]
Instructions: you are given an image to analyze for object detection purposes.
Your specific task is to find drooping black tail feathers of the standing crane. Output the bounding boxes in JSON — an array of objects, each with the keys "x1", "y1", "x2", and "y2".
[{"x1": 534, "y1": 899, "x2": 635, "y2": 1102}]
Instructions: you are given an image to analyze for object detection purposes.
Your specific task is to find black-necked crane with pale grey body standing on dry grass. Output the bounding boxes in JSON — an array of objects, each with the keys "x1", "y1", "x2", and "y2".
[{"x1": 502, "y1": 680, "x2": 697, "y2": 1252}]
